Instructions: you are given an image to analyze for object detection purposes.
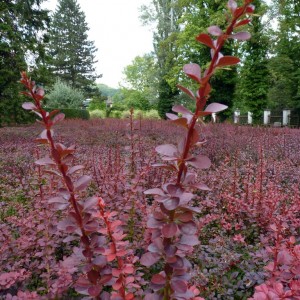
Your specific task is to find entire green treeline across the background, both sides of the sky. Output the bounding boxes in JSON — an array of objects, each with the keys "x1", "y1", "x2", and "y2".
[{"x1": 0, "y1": 0, "x2": 300, "y2": 125}]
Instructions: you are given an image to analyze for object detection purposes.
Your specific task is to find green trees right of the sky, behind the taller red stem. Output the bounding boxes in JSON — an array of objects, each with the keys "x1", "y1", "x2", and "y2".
[{"x1": 124, "y1": 0, "x2": 300, "y2": 120}]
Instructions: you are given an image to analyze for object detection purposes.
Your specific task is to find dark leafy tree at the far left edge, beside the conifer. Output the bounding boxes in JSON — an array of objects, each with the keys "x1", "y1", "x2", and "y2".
[{"x1": 0, "y1": 0, "x2": 49, "y2": 125}]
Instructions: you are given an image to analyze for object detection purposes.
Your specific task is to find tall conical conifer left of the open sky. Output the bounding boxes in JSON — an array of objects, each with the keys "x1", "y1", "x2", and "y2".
[{"x1": 49, "y1": 0, "x2": 99, "y2": 96}]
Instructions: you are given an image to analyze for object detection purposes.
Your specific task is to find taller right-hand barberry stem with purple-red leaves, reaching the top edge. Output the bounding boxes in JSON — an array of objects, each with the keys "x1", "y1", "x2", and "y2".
[{"x1": 141, "y1": 0, "x2": 254, "y2": 299}]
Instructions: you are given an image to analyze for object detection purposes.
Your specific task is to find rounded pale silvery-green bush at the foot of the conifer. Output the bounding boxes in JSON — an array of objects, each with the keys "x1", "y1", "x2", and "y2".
[{"x1": 47, "y1": 80, "x2": 84, "y2": 108}]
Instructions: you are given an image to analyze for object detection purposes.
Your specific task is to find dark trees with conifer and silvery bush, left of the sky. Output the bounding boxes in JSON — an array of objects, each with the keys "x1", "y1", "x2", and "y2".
[{"x1": 0, "y1": 0, "x2": 101, "y2": 125}]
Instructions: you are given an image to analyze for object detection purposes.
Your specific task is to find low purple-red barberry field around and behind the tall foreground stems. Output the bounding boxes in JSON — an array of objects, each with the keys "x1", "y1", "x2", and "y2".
[{"x1": 0, "y1": 119, "x2": 300, "y2": 299}]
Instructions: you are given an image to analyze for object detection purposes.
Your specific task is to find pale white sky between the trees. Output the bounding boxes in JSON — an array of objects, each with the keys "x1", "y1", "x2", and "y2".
[{"x1": 43, "y1": 0, "x2": 153, "y2": 88}]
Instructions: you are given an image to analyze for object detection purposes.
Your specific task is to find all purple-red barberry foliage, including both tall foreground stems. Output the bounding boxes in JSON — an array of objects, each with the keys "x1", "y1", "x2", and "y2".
[{"x1": 0, "y1": 0, "x2": 300, "y2": 300}]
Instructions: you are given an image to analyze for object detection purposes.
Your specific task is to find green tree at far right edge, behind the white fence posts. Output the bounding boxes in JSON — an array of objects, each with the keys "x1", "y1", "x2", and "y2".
[{"x1": 269, "y1": 0, "x2": 300, "y2": 115}]
